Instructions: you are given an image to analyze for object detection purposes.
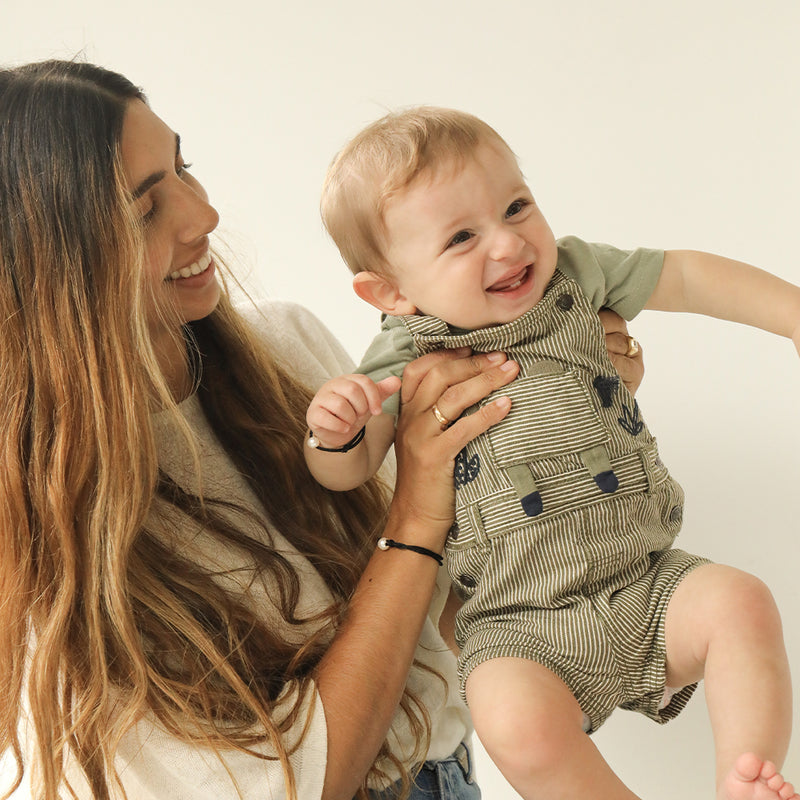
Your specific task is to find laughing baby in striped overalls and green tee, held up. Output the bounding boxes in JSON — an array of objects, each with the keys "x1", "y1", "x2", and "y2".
[{"x1": 305, "y1": 107, "x2": 800, "y2": 800}]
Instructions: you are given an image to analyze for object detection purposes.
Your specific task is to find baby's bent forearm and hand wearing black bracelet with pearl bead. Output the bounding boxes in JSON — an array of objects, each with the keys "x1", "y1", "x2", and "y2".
[{"x1": 303, "y1": 374, "x2": 400, "y2": 491}]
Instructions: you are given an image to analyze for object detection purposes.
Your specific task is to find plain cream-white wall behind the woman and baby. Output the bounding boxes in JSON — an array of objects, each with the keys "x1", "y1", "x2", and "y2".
[{"x1": 0, "y1": 0, "x2": 800, "y2": 800}]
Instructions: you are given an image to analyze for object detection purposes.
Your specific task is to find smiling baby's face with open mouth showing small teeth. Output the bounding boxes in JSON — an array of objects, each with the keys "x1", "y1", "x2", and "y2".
[{"x1": 384, "y1": 143, "x2": 557, "y2": 329}]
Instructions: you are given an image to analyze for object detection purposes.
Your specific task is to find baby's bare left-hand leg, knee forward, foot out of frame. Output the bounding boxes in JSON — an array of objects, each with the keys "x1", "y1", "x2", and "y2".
[{"x1": 466, "y1": 658, "x2": 636, "y2": 800}]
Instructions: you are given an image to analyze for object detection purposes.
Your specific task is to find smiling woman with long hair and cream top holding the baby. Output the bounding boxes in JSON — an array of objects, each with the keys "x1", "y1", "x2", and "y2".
[{"x1": 0, "y1": 62, "x2": 640, "y2": 800}]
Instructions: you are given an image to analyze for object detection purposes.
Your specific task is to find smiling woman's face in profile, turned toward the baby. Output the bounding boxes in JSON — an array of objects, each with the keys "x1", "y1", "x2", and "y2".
[{"x1": 121, "y1": 100, "x2": 220, "y2": 334}]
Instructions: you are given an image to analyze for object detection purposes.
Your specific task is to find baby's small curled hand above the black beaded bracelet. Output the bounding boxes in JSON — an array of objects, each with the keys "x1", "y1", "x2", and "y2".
[{"x1": 306, "y1": 375, "x2": 400, "y2": 448}]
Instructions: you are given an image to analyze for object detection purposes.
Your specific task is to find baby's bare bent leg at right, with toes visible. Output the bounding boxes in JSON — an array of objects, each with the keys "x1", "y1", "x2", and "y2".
[{"x1": 666, "y1": 564, "x2": 793, "y2": 800}]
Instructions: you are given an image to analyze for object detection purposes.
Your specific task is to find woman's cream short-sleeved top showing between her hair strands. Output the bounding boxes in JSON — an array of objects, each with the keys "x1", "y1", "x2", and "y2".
[{"x1": 15, "y1": 301, "x2": 471, "y2": 800}]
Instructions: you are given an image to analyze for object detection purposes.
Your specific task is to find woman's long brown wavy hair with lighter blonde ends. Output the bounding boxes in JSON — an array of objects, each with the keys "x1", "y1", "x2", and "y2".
[{"x1": 0, "y1": 61, "x2": 429, "y2": 800}]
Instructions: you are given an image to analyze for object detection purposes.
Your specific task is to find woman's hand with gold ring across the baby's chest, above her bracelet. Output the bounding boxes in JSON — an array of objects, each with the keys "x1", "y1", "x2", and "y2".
[{"x1": 393, "y1": 350, "x2": 519, "y2": 549}]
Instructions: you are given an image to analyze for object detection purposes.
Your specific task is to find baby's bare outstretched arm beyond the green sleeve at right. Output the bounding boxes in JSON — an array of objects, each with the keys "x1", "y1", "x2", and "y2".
[{"x1": 646, "y1": 250, "x2": 800, "y2": 353}]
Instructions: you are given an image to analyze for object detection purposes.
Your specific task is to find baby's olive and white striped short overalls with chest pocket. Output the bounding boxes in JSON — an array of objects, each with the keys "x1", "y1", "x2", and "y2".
[{"x1": 403, "y1": 271, "x2": 706, "y2": 730}]
